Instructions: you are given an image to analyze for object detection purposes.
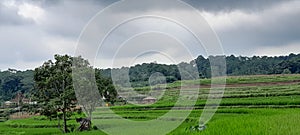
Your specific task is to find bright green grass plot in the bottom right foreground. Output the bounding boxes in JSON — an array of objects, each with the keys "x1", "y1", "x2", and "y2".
[{"x1": 170, "y1": 108, "x2": 300, "y2": 135}]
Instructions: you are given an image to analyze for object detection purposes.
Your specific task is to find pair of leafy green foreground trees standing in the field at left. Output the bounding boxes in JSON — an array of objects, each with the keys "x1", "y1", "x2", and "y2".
[{"x1": 32, "y1": 55, "x2": 117, "y2": 132}]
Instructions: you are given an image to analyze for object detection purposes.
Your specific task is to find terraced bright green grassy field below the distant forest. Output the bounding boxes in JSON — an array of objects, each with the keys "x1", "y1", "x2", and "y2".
[{"x1": 0, "y1": 75, "x2": 300, "y2": 135}]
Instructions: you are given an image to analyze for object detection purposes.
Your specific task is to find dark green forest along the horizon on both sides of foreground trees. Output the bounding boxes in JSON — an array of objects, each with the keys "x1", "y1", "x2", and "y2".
[{"x1": 0, "y1": 54, "x2": 300, "y2": 102}]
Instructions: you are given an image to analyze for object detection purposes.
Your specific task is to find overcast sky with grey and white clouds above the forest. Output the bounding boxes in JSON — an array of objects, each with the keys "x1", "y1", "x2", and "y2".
[{"x1": 0, "y1": 0, "x2": 300, "y2": 70}]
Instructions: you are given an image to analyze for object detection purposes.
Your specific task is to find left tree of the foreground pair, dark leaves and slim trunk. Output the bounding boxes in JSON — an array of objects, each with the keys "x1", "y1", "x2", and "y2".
[{"x1": 34, "y1": 55, "x2": 76, "y2": 132}]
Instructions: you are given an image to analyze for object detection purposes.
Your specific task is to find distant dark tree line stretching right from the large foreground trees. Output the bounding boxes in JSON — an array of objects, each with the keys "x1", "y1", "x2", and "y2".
[{"x1": 101, "y1": 54, "x2": 300, "y2": 87}]
